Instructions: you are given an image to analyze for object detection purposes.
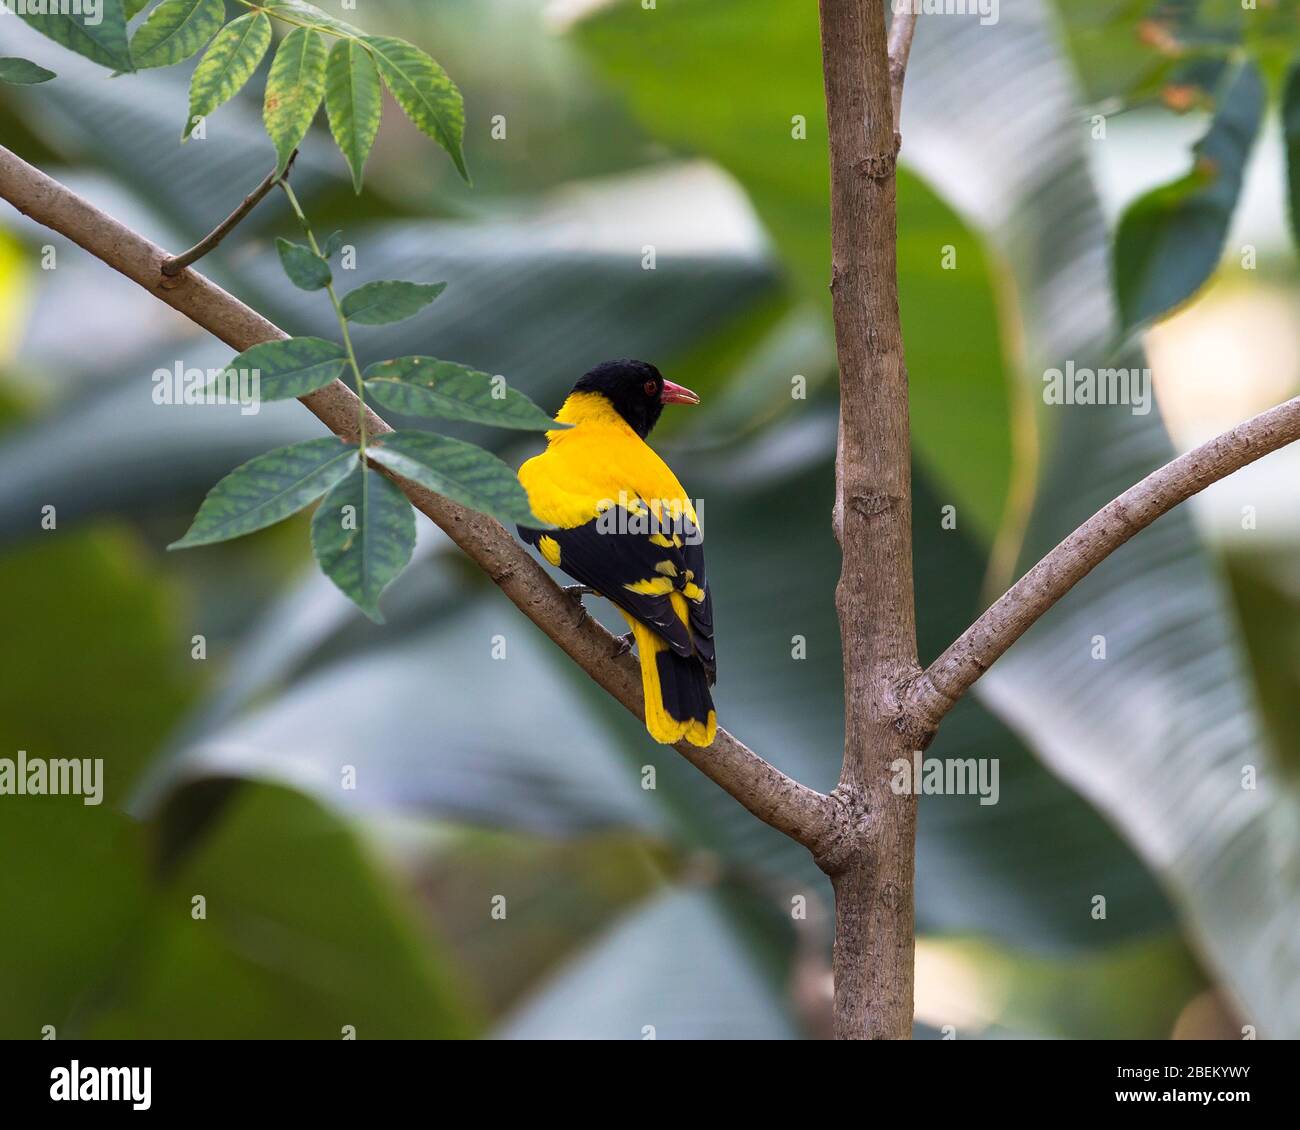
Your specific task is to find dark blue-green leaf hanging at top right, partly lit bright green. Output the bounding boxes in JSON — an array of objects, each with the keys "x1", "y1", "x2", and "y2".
[{"x1": 1115, "y1": 62, "x2": 1265, "y2": 330}]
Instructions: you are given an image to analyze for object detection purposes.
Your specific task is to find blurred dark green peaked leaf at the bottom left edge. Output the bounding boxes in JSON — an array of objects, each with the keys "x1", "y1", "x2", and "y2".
[{"x1": 83, "y1": 785, "x2": 478, "y2": 1040}]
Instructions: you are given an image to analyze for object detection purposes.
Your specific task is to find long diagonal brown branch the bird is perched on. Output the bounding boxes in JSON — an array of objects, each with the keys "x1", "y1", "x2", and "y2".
[{"x1": 0, "y1": 147, "x2": 844, "y2": 856}]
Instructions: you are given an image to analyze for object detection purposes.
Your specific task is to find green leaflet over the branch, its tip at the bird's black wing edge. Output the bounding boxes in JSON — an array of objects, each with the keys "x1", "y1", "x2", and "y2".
[{"x1": 369, "y1": 432, "x2": 547, "y2": 528}]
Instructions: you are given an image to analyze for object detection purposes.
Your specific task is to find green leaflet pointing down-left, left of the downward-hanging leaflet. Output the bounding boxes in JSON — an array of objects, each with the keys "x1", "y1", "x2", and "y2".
[{"x1": 168, "y1": 436, "x2": 356, "y2": 549}]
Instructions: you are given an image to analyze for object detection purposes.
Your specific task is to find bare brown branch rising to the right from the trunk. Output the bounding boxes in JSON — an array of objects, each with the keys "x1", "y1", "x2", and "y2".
[{"x1": 896, "y1": 397, "x2": 1300, "y2": 745}]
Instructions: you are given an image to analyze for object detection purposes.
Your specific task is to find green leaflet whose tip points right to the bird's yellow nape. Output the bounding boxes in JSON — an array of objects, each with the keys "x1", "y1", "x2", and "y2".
[{"x1": 365, "y1": 358, "x2": 563, "y2": 432}]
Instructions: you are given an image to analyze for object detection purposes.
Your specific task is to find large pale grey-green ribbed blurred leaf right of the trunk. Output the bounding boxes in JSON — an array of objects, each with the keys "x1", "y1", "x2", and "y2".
[{"x1": 904, "y1": 4, "x2": 1300, "y2": 1036}]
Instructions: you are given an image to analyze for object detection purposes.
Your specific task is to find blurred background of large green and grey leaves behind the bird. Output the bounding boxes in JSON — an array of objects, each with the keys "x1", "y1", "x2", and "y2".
[{"x1": 0, "y1": 0, "x2": 1300, "y2": 1039}]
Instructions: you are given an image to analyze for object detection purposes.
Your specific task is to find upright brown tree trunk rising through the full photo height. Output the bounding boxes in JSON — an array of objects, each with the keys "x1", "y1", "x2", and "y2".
[{"x1": 820, "y1": 0, "x2": 917, "y2": 1039}]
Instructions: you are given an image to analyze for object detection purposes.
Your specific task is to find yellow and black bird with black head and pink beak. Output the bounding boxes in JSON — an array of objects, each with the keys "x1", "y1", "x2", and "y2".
[{"x1": 519, "y1": 359, "x2": 718, "y2": 746}]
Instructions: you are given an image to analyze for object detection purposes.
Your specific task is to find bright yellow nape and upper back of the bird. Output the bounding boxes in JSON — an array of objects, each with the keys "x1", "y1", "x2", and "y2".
[{"x1": 519, "y1": 393, "x2": 697, "y2": 529}]
